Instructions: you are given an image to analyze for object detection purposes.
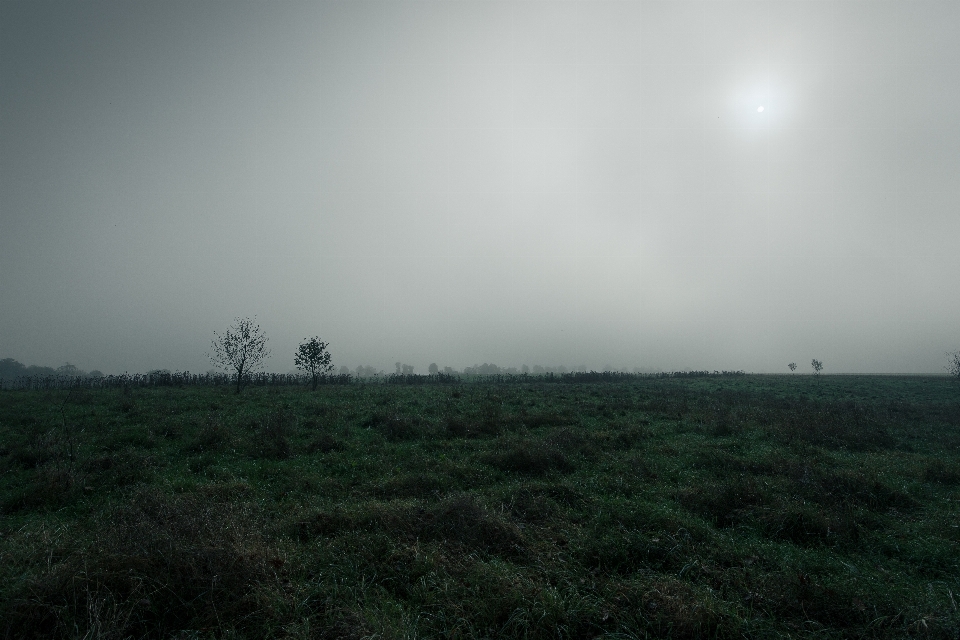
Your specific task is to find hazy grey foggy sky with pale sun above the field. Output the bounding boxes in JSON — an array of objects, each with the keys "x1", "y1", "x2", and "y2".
[{"x1": 0, "y1": 0, "x2": 960, "y2": 374}]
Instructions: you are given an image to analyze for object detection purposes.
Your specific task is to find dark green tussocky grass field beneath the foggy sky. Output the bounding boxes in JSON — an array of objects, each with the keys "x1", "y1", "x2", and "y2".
[{"x1": 0, "y1": 375, "x2": 960, "y2": 640}]
